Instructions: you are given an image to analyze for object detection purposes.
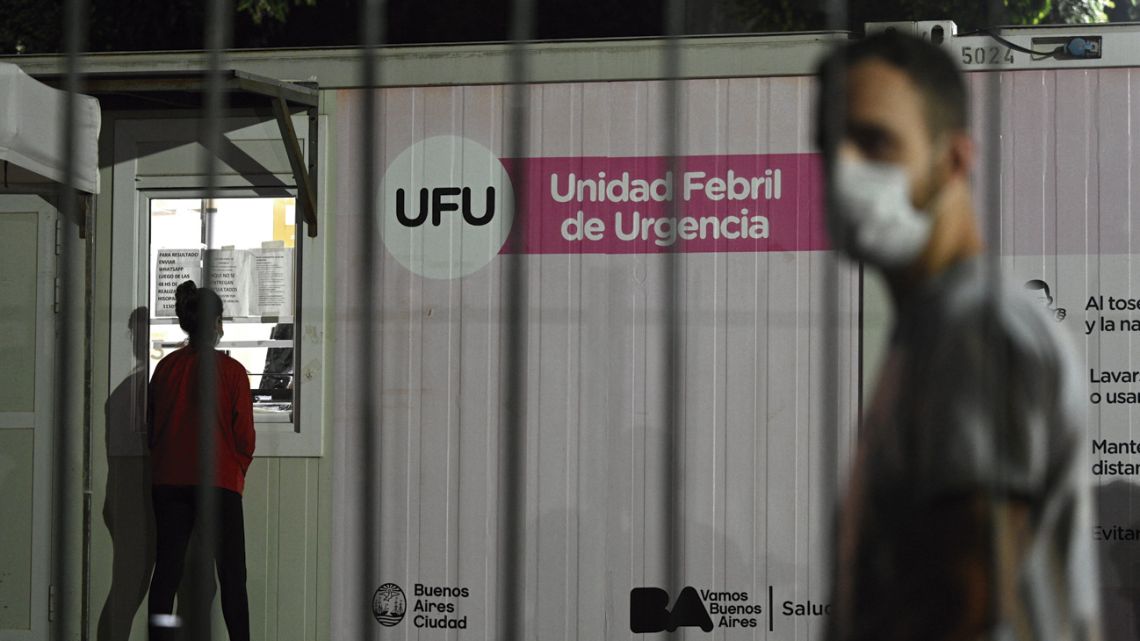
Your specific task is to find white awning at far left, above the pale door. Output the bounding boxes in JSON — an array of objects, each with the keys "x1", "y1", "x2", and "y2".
[{"x1": 0, "y1": 63, "x2": 100, "y2": 194}]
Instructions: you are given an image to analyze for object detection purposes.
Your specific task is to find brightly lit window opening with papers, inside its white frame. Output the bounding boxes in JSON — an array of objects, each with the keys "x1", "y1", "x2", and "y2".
[{"x1": 148, "y1": 197, "x2": 299, "y2": 423}]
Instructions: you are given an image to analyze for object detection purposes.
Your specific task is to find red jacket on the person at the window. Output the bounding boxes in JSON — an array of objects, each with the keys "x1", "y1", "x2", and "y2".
[{"x1": 147, "y1": 347, "x2": 255, "y2": 494}]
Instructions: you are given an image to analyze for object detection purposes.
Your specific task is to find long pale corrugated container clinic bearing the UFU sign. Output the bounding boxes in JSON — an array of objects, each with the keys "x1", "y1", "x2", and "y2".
[{"x1": 11, "y1": 23, "x2": 1140, "y2": 640}]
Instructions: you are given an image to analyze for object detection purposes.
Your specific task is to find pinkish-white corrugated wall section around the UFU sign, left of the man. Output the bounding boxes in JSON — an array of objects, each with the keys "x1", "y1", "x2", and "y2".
[{"x1": 333, "y1": 78, "x2": 858, "y2": 640}]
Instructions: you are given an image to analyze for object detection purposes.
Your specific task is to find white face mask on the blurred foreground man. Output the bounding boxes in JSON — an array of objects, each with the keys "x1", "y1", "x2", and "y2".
[{"x1": 828, "y1": 159, "x2": 934, "y2": 268}]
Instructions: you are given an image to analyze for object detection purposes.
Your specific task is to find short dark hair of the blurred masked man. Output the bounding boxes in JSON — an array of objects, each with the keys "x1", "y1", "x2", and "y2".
[{"x1": 816, "y1": 31, "x2": 968, "y2": 149}]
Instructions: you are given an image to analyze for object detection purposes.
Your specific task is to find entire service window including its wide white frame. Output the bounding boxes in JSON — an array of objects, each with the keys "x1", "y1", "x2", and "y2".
[{"x1": 108, "y1": 114, "x2": 326, "y2": 456}]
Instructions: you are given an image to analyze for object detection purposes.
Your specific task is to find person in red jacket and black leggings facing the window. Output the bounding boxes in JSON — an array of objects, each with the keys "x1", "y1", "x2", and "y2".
[{"x1": 147, "y1": 281, "x2": 255, "y2": 641}]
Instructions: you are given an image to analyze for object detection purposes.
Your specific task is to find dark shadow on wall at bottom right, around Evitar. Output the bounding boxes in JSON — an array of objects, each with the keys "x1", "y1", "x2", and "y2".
[{"x1": 1093, "y1": 481, "x2": 1140, "y2": 641}]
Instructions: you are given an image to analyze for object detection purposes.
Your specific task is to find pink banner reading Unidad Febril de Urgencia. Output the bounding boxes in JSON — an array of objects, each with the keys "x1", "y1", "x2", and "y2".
[{"x1": 503, "y1": 154, "x2": 828, "y2": 254}]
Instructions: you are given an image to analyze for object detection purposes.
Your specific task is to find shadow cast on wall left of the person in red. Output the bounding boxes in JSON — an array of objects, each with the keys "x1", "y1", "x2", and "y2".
[{"x1": 97, "y1": 307, "x2": 154, "y2": 641}]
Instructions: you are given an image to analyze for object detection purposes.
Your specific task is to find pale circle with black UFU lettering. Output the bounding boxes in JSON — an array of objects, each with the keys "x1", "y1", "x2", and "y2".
[{"x1": 380, "y1": 136, "x2": 514, "y2": 278}]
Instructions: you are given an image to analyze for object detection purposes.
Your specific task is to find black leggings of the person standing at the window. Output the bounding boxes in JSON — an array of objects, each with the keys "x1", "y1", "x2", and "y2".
[{"x1": 147, "y1": 485, "x2": 250, "y2": 641}]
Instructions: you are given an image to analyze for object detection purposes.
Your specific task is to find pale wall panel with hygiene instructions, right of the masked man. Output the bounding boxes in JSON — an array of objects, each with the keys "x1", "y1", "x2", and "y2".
[{"x1": 971, "y1": 68, "x2": 1140, "y2": 641}]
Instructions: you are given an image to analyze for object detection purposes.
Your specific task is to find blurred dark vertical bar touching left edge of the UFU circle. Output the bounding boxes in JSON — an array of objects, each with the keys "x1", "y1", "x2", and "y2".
[{"x1": 350, "y1": 0, "x2": 385, "y2": 639}]
